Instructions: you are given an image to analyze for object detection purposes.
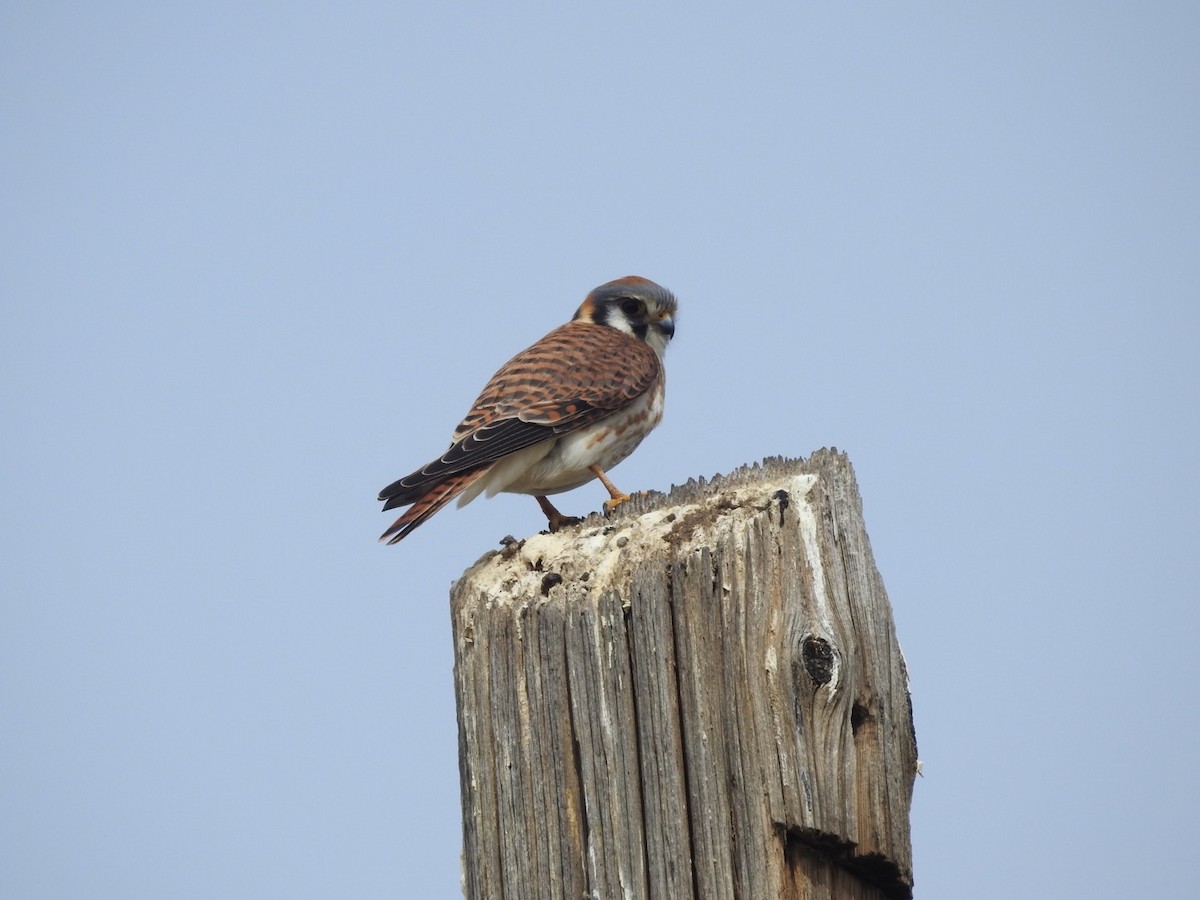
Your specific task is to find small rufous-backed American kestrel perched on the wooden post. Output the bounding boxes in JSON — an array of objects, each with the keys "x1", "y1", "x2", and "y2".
[{"x1": 379, "y1": 275, "x2": 676, "y2": 544}]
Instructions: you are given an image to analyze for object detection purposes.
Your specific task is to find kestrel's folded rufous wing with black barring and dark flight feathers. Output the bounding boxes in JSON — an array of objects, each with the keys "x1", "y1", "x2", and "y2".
[{"x1": 379, "y1": 320, "x2": 662, "y2": 510}]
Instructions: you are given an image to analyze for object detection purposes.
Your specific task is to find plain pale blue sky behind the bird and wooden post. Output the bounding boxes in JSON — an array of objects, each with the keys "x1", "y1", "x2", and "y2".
[{"x1": 0, "y1": 1, "x2": 1200, "y2": 900}]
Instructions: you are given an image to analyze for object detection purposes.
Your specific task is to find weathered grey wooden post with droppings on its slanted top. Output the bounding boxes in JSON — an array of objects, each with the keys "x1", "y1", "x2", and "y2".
[{"x1": 451, "y1": 450, "x2": 917, "y2": 900}]
